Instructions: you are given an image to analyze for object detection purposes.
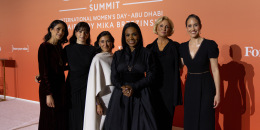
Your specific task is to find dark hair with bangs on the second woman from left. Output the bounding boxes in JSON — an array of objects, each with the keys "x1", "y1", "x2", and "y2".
[{"x1": 70, "y1": 22, "x2": 90, "y2": 45}]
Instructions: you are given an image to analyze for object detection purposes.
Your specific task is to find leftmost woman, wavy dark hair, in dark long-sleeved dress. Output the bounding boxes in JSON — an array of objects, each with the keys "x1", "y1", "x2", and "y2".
[{"x1": 38, "y1": 20, "x2": 68, "y2": 130}]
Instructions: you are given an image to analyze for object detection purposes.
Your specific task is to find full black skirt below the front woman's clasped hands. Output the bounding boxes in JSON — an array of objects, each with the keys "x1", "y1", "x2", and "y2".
[{"x1": 104, "y1": 88, "x2": 157, "y2": 130}]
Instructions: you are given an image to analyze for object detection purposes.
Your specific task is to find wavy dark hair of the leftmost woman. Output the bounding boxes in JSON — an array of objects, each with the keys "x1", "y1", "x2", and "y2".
[{"x1": 43, "y1": 20, "x2": 69, "y2": 44}]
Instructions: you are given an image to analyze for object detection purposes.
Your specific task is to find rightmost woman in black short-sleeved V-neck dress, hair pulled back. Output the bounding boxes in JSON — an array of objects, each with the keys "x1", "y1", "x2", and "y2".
[{"x1": 180, "y1": 14, "x2": 220, "y2": 130}]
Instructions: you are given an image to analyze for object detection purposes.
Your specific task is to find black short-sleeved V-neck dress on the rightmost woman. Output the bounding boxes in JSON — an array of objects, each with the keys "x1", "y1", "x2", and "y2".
[{"x1": 180, "y1": 39, "x2": 219, "y2": 130}]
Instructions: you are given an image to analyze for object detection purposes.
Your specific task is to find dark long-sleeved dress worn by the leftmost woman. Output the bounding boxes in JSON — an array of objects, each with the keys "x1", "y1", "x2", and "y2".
[{"x1": 38, "y1": 42, "x2": 67, "y2": 130}]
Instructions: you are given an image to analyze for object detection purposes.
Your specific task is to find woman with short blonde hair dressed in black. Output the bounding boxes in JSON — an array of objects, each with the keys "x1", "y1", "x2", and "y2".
[{"x1": 147, "y1": 16, "x2": 182, "y2": 130}]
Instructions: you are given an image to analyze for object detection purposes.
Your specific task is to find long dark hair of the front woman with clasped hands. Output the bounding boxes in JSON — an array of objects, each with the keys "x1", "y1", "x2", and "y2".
[{"x1": 121, "y1": 22, "x2": 143, "y2": 50}]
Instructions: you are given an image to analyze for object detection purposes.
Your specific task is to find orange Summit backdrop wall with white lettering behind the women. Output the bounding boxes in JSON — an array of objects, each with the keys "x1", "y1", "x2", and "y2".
[{"x1": 0, "y1": 0, "x2": 260, "y2": 130}]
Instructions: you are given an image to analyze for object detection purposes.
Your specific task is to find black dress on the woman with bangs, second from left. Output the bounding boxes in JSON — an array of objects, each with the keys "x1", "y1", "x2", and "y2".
[{"x1": 64, "y1": 43, "x2": 96, "y2": 130}]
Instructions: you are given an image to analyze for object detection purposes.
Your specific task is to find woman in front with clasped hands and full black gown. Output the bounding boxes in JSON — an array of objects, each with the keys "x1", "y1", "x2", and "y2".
[{"x1": 104, "y1": 22, "x2": 157, "y2": 130}]
